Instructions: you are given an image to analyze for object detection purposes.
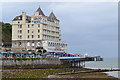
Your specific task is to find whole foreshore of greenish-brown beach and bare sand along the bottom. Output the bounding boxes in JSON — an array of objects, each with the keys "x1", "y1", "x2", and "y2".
[{"x1": 2, "y1": 68, "x2": 117, "y2": 80}]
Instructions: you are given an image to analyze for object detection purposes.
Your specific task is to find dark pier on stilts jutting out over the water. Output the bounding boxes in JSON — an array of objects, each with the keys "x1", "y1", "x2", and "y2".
[{"x1": 59, "y1": 56, "x2": 103, "y2": 68}]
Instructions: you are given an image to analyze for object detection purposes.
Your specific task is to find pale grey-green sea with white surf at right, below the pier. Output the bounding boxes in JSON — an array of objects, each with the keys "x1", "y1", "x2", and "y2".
[{"x1": 85, "y1": 58, "x2": 120, "y2": 78}]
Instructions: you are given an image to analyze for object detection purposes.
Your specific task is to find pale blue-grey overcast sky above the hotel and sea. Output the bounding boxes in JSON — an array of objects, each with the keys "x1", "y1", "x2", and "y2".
[{"x1": 0, "y1": 2, "x2": 118, "y2": 57}]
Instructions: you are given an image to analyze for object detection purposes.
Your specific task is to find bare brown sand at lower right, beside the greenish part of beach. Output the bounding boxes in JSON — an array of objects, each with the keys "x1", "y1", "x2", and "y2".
[{"x1": 48, "y1": 68, "x2": 118, "y2": 80}]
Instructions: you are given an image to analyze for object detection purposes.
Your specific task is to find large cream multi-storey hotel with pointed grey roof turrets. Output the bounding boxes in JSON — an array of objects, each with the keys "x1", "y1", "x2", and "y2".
[{"x1": 12, "y1": 7, "x2": 67, "y2": 52}]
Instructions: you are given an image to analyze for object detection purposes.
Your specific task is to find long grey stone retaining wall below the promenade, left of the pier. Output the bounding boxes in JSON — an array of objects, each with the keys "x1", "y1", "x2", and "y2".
[{"x1": 2, "y1": 59, "x2": 61, "y2": 67}]
